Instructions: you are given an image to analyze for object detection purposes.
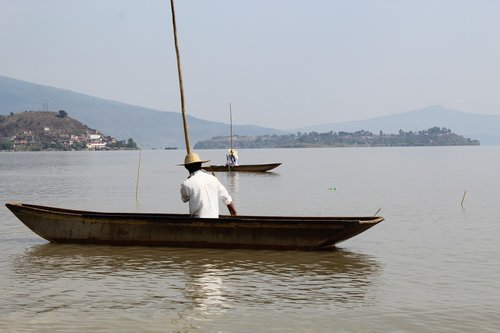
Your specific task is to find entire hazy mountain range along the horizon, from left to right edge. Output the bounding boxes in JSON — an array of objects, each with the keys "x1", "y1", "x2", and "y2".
[{"x1": 0, "y1": 76, "x2": 500, "y2": 149}]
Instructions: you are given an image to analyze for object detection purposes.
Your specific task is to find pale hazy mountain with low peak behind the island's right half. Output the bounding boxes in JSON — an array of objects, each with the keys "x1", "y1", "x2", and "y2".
[{"x1": 293, "y1": 105, "x2": 500, "y2": 145}]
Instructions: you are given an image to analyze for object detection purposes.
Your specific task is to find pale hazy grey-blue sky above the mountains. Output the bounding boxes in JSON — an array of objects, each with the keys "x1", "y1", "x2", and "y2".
[{"x1": 0, "y1": 0, "x2": 500, "y2": 128}]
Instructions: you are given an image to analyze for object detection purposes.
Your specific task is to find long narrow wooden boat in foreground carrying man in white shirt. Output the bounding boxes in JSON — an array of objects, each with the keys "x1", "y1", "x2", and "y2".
[{"x1": 6, "y1": 202, "x2": 384, "y2": 250}]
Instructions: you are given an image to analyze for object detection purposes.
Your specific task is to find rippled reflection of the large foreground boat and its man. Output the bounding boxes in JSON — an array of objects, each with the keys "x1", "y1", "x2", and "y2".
[{"x1": 10, "y1": 244, "x2": 382, "y2": 314}]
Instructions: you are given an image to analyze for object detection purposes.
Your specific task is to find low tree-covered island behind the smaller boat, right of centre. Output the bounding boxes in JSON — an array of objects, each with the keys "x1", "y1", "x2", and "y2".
[{"x1": 194, "y1": 127, "x2": 480, "y2": 149}]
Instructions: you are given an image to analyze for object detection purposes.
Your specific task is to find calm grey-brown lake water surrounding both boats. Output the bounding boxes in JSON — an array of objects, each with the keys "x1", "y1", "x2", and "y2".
[{"x1": 0, "y1": 146, "x2": 500, "y2": 332}]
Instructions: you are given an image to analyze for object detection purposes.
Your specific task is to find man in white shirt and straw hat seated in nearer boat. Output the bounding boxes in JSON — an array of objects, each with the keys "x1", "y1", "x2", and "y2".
[{"x1": 180, "y1": 153, "x2": 236, "y2": 218}]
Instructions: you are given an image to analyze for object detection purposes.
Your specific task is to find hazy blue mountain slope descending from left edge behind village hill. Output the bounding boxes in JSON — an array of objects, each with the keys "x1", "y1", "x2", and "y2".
[{"x1": 0, "y1": 76, "x2": 284, "y2": 149}]
